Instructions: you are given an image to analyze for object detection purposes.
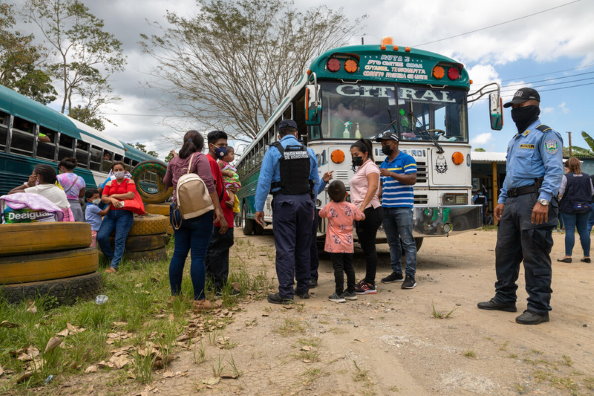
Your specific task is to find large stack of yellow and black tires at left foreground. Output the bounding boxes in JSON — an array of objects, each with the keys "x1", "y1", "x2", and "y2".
[{"x1": 0, "y1": 222, "x2": 101, "y2": 304}]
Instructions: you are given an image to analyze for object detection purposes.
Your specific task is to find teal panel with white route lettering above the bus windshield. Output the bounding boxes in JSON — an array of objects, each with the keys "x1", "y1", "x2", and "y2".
[{"x1": 310, "y1": 45, "x2": 469, "y2": 88}]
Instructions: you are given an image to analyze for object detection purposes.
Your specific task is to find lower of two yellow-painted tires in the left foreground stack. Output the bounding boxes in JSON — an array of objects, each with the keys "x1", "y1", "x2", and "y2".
[{"x1": 0, "y1": 248, "x2": 99, "y2": 284}]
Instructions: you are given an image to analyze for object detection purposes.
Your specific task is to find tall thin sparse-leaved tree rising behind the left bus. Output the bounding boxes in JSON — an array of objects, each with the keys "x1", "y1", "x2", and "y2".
[{"x1": 25, "y1": 0, "x2": 126, "y2": 115}]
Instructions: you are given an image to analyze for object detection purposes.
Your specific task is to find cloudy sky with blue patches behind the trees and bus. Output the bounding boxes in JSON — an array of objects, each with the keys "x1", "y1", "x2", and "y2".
[{"x1": 20, "y1": 0, "x2": 594, "y2": 153}]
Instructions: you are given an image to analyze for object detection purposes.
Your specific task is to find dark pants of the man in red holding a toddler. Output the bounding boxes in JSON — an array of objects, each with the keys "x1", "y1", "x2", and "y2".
[{"x1": 204, "y1": 227, "x2": 233, "y2": 291}]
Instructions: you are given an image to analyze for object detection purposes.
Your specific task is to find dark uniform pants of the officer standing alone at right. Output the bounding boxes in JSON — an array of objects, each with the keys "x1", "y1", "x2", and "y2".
[{"x1": 495, "y1": 193, "x2": 559, "y2": 315}]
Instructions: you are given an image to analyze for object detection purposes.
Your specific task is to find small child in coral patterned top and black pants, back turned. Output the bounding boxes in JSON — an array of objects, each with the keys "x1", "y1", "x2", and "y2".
[{"x1": 320, "y1": 180, "x2": 365, "y2": 303}]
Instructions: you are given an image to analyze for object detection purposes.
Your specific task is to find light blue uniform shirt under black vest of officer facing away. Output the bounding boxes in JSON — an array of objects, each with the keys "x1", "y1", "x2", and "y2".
[{"x1": 255, "y1": 135, "x2": 320, "y2": 212}]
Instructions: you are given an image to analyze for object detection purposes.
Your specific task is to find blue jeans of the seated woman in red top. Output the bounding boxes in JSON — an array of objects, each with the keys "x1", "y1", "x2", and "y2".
[{"x1": 97, "y1": 209, "x2": 134, "y2": 269}]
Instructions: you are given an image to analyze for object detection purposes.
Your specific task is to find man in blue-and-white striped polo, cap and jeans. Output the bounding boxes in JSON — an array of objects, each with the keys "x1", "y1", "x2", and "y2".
[{"x1": 376, "y1": 131, "x2": 417, "y2": 289}]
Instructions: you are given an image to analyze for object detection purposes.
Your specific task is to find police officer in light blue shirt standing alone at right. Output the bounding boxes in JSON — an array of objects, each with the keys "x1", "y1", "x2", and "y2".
[{"x1": 478, "y1": 88, "x2": 563, "y2": 325}]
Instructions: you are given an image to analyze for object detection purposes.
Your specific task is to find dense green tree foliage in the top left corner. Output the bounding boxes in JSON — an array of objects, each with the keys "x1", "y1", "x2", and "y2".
[{"x1": 0, "y1": 3, "x2": 57, "y2": 104}]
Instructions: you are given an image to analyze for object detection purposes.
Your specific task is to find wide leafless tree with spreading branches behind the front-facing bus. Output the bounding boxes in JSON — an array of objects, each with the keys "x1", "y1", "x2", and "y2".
[{"x1": 141, "y1": 0, "x2": 365, "y2": 137}]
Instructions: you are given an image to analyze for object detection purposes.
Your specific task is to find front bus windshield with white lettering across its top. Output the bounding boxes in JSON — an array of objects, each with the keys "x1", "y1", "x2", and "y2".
[{"x1": 312, "y1": 82, "x2": 468, "y2": 143}]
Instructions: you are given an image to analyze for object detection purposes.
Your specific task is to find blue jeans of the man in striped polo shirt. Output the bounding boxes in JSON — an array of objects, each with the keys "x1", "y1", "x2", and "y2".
[{"x1": 383, "y1": 207, "x2": 417, "y2": 278}]
